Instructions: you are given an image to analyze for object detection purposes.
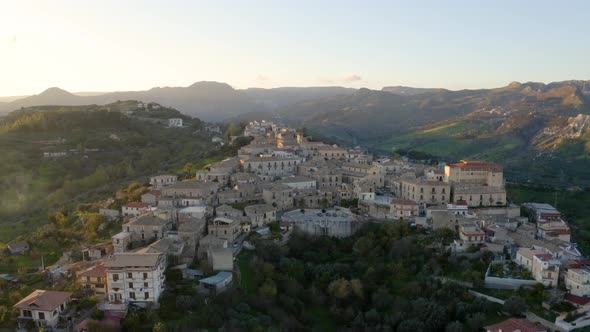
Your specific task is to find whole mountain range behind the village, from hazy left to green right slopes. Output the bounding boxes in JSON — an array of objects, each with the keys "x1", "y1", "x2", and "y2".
[{"x1": 0, "y1": 81, "x2": 590, "y2": 188}]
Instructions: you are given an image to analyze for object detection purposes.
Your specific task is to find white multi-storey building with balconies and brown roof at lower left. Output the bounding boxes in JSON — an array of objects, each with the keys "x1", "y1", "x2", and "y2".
[{"x1": 105, "y1": 253, "x2": 166, "y2": 304}]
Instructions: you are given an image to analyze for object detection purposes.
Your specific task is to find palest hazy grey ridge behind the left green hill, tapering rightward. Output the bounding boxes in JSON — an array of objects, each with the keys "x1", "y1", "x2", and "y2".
[{"x1": 0, "y1": 81, "x2": 355, "y2": 121}]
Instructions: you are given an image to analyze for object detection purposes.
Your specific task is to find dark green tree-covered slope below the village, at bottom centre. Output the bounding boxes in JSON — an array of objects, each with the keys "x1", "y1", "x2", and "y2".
[{"x1": 138, "y1": 222, "x2": 522, "y2": 332}]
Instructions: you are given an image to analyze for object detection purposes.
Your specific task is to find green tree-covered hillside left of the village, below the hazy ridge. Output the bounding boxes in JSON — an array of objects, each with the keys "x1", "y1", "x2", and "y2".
[{"x1": 0, "y1": 102, "x2": 222, "y2": 242}]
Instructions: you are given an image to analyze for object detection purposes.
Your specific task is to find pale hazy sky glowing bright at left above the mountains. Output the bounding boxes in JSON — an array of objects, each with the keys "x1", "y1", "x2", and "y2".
[{"x1": 0, "y1": 0, "x2": 590, "y2": 96}]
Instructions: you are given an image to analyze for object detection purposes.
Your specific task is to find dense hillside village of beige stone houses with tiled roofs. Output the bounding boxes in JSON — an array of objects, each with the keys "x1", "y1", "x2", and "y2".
[{"x1": 6, "y1": 119, "x2": 590, "y2": 330}]
